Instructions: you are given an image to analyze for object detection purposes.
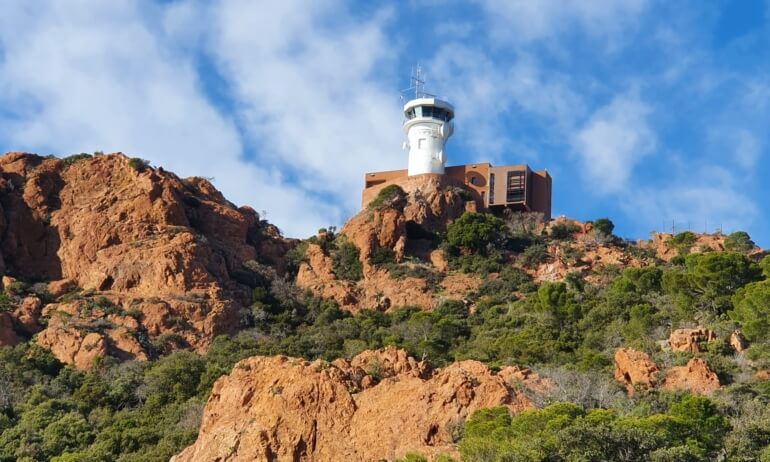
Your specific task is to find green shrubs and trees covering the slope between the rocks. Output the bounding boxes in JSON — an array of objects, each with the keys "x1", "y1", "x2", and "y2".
[{"x1": 0, "y1": 208, "x2": 770, "y2": 461}]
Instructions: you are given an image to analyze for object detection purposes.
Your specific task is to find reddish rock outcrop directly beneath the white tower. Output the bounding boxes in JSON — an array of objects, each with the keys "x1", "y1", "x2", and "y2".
[{"x1": 296, "y1": 175, "x2": 472, "y2": 312}]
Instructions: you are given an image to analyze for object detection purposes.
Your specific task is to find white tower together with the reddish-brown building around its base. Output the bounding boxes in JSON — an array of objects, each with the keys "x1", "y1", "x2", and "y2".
[{"x1": 362, "y1": 69, "x2": 551, "y2": 220}]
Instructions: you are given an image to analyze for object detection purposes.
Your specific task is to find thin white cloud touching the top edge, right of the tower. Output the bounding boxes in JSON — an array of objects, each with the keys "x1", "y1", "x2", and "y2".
[{"x1": 476, "y1": 0, "x2": 648, "y2": 43}]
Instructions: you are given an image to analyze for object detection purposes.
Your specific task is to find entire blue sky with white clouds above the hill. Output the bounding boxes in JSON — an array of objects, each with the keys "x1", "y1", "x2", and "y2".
[{"x1": 0, "y1": 0, "x2": 770, "y2": 247}]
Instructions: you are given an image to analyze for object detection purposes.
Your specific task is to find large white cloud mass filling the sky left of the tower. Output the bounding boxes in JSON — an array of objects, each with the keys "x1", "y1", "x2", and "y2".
[{"x1": 0, "y1": 0, "x2": 396, "y2": 235}]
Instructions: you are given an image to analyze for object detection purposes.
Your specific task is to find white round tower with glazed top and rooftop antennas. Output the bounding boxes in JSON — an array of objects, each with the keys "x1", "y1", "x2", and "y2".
[{"x1": 404, "y1": 66, "x2": 455, "y2": 176}]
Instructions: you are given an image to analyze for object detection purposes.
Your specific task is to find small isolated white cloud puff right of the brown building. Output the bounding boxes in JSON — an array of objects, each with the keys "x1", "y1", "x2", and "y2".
[{"x1": 572, "y1": 96, "x2": 656, "y2": 194}]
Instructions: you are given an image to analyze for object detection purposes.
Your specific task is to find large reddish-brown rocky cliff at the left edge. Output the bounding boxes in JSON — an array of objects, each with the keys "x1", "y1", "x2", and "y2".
[{"x1": 0, "y1": 153, "x2": 288, "y2": 363}]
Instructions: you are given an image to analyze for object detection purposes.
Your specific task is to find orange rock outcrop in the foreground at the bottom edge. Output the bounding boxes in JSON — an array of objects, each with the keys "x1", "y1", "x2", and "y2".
[{"x1": 172, "y1": 349, "x2": 530, "y2": 462}]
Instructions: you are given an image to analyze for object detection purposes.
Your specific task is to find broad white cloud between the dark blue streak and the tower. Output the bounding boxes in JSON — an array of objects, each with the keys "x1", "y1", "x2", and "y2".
[{"x1": 204, "y1": 0, "x2": 405, "y2": 212}]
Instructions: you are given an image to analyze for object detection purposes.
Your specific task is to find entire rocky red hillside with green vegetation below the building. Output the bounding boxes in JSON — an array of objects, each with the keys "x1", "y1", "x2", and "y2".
[{"x1": 0, "y1": 153, "x2": 770, "y2": 461}]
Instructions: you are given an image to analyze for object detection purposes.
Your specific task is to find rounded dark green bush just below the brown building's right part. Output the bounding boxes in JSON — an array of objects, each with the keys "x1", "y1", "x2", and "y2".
[{"x1": 447, "y1": 212, "x2": 508, "y2": 255}]
